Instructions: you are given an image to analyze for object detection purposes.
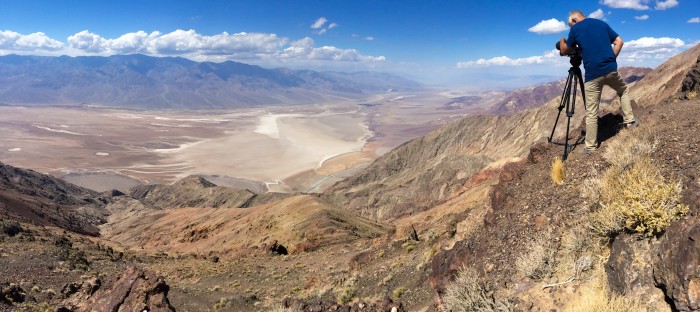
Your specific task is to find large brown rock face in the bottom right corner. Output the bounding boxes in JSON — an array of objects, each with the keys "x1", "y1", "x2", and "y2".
[{"x1": 654, "y1": 220, "x2": 700, "y2": 311}]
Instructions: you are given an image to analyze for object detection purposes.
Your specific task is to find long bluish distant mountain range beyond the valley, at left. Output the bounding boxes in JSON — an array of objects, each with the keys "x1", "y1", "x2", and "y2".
[{"x1": 0, "y1": 54, "x2": 423, "y2": 109}]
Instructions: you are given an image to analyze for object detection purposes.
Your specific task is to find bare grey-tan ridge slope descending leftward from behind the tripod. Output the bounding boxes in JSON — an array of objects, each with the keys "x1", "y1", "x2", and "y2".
[{"x1": 323, "y1": 98, "x2": 582, "y2": 220}]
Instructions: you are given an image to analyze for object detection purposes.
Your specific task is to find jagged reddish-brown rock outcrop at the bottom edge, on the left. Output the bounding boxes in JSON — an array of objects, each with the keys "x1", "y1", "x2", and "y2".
[{"x1": 63, "y1": 267, "x2": 175, "y2": 312}]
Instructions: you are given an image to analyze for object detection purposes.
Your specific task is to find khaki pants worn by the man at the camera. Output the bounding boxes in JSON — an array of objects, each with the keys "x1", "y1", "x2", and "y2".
[{"x1": 584, "y1": 71, "x2": 634, "y2": 150}]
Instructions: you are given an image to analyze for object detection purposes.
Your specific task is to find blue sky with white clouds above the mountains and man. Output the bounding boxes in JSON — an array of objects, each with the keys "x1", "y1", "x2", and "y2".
[{"x1": 0, "y1": 0, "x2": 700, "y2": 86}]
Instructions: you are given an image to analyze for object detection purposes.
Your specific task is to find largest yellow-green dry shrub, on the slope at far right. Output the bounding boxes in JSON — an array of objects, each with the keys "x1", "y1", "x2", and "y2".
[{"x1": 591, "y1": 159, "x2": 689, "y2": 236}]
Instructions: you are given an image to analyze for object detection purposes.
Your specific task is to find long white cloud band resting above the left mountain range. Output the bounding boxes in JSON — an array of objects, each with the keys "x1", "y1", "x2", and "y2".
[{"x1": 0, "y1": 29, "x2": 386, "y2": 68}]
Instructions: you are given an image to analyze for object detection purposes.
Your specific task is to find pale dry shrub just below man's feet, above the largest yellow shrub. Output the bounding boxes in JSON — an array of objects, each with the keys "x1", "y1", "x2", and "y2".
[{"x1": 603, "y1": 129, "x2": 657, "y2": 168}]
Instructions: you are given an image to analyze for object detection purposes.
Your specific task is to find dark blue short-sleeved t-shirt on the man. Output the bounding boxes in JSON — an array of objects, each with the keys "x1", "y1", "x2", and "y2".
[{"x1": 566, "y1": 18, "x2": 618, "y2": 82}]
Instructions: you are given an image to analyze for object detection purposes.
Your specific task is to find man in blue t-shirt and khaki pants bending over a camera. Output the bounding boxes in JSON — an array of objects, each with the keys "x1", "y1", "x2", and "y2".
[{"x1": 559, "y1": 11, "x2": 639, "y2": 154}]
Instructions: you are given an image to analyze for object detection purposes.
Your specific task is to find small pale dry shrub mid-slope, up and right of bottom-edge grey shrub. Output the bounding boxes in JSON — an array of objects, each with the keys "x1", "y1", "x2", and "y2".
[{"x1": 515, "y1": 234, "x2": 556, "y2": 281}]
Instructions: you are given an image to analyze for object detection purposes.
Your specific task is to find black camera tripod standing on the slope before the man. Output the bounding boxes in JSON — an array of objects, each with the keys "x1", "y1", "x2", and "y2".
[{"x1": 548, "y1": 57, "x2": 586, "y2": 160}]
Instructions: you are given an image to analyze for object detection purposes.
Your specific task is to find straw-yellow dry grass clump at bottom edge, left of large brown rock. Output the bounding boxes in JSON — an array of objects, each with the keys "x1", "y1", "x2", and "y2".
[{"x1": 564, "y1": 269, "x2": 647, "y2": 312}]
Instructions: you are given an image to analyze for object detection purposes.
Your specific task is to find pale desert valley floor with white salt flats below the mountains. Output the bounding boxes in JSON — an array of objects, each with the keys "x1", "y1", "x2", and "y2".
[{"x1": 0, "y1": 92, "x2": 489, "y2": 193}]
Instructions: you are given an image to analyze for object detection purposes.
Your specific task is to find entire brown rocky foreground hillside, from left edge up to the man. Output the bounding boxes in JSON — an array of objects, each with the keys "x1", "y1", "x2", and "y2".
[{"x1": 0, "y1": 46, "x2": 700, "y2": 311}]
